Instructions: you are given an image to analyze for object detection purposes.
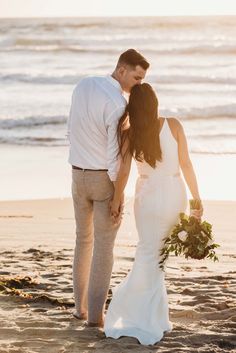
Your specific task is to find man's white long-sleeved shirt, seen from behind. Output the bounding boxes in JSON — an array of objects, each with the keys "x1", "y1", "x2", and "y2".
[{"x1": 68, "y1": 76, "x2": 127, "y2": 181}]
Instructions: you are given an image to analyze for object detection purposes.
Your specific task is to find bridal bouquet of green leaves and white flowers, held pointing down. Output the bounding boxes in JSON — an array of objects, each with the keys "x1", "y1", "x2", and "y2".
[{"x1": 159, "y1": 200, "x2": 220, "y2": 270}]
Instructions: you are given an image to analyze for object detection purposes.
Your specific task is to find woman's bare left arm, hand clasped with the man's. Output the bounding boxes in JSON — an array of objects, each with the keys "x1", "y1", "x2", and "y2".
[{"x1": 110, "y1": 138, "x2": 132, "y2": 219}]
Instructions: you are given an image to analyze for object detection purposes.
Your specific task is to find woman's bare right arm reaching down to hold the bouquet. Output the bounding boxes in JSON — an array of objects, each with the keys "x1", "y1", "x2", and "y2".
[{"x1": 175, "y1": 119, "x2": 203, "y2": 217}]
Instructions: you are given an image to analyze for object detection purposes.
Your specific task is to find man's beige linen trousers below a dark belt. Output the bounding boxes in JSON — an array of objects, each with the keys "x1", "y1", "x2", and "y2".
[{"x1": 72, "y1": 169, "x2": 119, "y2": 323}]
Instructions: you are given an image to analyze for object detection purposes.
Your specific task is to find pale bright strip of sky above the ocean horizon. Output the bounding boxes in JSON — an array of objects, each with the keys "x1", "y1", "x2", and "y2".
[{"x1": 0, "y1": 0, "x2": 236, "y2": 17}]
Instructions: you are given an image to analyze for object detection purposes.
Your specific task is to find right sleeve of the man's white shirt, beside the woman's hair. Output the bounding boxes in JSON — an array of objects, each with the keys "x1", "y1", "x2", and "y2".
[{"x1": 107, "y1": 106, "x2": 125, "y2": 181}]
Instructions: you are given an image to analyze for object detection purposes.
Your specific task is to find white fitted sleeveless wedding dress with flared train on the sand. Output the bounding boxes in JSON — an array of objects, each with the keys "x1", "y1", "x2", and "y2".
[{"x1": 104, "y1": 119, "x2": 187, "y2": 345}]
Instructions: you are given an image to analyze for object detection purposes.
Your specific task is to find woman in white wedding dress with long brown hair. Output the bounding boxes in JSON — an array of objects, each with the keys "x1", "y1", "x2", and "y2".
[{"x1": 104, "y1": 83, "x2": 202, "y2": 344}]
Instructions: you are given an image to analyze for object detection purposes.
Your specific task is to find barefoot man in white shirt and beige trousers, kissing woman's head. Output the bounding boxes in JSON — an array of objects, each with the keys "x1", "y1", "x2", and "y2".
[{"x1": 68, "y1": 49, "x2": 149, "y2": 327}]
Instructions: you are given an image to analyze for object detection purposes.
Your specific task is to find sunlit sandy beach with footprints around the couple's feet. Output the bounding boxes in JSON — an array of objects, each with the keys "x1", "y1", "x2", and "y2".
[{"x1": 0, "y1": 198, "x2": 236, "y2": 353}]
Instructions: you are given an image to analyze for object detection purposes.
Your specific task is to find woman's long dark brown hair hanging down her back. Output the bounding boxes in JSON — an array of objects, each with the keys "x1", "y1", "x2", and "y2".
[{"x1": 117, "y1": 83, "x2": 162, "y2": 168}]
